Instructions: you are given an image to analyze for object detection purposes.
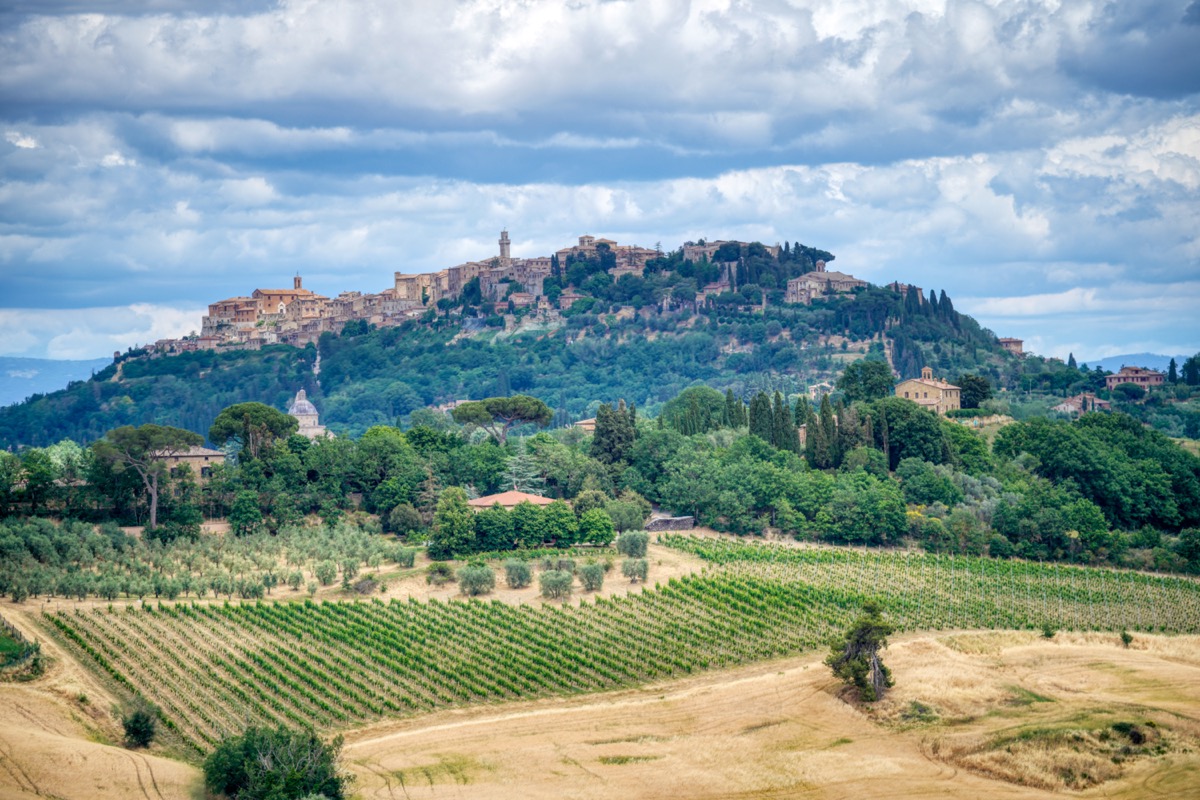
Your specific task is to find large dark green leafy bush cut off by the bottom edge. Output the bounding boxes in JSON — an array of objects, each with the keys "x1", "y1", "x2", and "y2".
[{"x1": 204, "y1": 727, "x2": 353, "y2": 800}]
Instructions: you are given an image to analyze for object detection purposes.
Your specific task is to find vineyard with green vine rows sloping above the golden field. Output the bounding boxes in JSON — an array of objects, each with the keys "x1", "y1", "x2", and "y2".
[{"x1": 49, "y1": 536, "x2": 1200, "y2": 752}]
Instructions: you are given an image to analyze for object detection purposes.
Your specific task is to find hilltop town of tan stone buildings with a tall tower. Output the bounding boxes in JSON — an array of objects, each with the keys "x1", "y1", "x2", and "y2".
[{"x1": 145, "y1": 230, "x2": 888, "y2": 354}]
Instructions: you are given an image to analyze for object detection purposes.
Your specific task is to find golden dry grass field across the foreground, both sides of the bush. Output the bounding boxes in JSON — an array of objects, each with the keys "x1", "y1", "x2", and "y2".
[{"x1": 0, "y1": 632, "x2": 1200, "y2": 800}]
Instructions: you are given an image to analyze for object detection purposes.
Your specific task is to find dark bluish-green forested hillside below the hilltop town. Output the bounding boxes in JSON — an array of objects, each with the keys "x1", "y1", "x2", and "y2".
[{"x1": 0, "y1": 285, "x2": 1027, "y2": 447}]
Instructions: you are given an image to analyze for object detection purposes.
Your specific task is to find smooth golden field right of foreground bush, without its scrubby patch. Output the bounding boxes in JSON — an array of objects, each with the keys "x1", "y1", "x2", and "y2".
[{"x1": 346, "y1": 633, "x2": 1200, "y2": 800}]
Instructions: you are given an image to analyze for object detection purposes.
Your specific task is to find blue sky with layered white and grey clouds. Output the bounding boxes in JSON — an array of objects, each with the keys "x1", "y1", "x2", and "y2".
[{"x1": 0, "y1": 0, "x2": 1200, "y2": 360}]
